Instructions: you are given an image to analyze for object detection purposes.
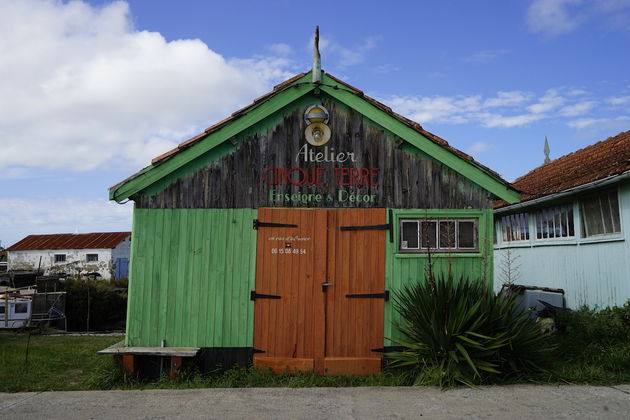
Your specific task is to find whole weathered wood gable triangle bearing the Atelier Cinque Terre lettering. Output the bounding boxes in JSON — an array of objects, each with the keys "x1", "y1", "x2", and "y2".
[{"x1": 132, "y1": 93, "x2": 491, "y2": 209}]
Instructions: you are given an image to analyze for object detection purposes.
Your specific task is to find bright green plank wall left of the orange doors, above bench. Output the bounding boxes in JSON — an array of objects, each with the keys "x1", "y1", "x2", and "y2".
[{"x1": 126, "y1": 209, "x2": 256, "y2": 347}]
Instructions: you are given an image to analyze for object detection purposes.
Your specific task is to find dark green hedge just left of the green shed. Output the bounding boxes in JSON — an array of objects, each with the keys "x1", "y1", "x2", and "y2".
[{"x1": 65, "y1": 279, "x2": 127, "y2": 331}]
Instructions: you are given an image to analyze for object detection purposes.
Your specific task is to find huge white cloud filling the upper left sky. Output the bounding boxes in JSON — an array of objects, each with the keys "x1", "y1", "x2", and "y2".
[{"x1": 0, "y1": 0, "x2": 293, "y2": 170}]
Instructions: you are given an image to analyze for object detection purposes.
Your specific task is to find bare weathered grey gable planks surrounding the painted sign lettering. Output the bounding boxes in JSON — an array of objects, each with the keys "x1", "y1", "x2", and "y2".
[{"x1": 134, "y1": 101, "x2": 491, "y2": 208}]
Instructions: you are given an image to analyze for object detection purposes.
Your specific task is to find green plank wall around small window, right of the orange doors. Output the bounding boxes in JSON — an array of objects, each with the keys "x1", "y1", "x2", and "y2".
[{"x1": 384, "y1": 209, "x2": 493, "y2": 346}]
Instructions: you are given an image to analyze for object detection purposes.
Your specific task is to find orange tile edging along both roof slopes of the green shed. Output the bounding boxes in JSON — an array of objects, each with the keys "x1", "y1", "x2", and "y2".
[{"x1": 151, "y1": 73, "x2": 510, "y2": 186}]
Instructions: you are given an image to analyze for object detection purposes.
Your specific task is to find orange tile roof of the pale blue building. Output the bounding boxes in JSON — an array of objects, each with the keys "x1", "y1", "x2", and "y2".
[{"x1": 495, "y1": 131, "x2": 630, "y2": 208}]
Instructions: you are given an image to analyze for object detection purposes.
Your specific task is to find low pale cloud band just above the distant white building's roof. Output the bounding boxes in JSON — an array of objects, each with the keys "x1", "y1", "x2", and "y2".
[{"x1": 0, "y1": 197, "x2": 133, "y2": 248}]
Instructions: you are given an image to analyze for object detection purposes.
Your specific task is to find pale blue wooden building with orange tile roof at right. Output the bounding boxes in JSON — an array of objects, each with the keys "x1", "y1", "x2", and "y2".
[{"x1": 494, "y1": 131, "x2": 630, "y2": 308}]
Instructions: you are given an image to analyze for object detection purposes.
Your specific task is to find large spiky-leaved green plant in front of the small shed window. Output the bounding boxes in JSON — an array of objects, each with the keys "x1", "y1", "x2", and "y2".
[{"x1": 388, "y1": 276, "x2": 554, "y2": 387}]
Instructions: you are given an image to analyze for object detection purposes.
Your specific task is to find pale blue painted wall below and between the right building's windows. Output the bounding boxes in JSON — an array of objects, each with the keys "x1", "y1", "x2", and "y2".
[{"x1": 494, "y1": 180, "x2": 630, "y2": 308}]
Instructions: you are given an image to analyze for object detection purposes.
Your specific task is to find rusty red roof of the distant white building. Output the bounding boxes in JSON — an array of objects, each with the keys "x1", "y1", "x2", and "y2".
[{"x1": 7, "y1": 232, "x2": 131, "y2": 251}]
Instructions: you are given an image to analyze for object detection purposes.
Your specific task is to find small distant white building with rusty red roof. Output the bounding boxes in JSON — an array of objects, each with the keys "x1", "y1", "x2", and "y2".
[{"x1": 7, "y1": 232, "x2": 131, "y2": 280}]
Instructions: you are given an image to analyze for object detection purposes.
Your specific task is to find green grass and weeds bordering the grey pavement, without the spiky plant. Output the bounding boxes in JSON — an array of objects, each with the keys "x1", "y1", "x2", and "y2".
[{"x1": 0, "y1": 303, "x2": 630, "y2": 392}]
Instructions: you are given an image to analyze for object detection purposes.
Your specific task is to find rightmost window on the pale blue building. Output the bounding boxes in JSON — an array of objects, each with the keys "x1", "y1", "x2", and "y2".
[{"x1": 580, "y1": 190, "x2": 621, "y2": 238}]
